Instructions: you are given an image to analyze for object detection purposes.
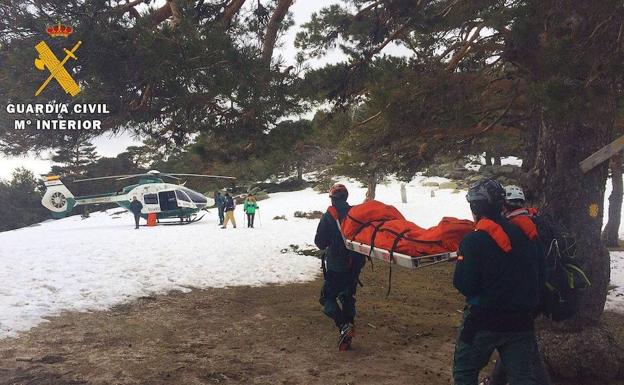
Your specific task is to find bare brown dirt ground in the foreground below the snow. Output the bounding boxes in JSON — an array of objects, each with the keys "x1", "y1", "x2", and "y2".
[{"x1": 0, "y1": 264, "x2": 624, "y2": 385}]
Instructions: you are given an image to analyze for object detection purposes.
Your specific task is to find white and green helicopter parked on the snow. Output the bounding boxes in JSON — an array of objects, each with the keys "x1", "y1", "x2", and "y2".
[{"x1": 41, "y1": 170, "x2": 236, "y2": 224}]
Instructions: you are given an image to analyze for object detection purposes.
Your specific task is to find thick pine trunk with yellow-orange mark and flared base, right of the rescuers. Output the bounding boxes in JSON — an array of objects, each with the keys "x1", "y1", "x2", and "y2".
[{"x1": 534, "y1": 104, "x2": 624, "y2": 381}]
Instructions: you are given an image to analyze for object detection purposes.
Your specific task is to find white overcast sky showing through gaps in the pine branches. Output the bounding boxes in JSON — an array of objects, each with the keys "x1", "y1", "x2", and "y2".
[{"x1": 0, "y1": 0, "x2": 405, "y2": 179}]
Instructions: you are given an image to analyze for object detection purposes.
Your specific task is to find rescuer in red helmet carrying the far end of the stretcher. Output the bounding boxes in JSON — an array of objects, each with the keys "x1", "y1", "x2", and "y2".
[{"x1": 314, "y1": 184, "x2": 365, "y2": 350}]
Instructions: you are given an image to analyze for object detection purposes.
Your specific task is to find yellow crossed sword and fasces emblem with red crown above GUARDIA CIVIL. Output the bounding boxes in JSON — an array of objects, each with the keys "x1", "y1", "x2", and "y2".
[{"x1": 35, "y1": 22, "x2": 82, "y2": 97}]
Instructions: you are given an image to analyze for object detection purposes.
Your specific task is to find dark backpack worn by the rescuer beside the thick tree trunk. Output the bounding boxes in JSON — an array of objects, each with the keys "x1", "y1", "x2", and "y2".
[{"x1": 533, "y1": 215, "x2": 591, "y2": 321}]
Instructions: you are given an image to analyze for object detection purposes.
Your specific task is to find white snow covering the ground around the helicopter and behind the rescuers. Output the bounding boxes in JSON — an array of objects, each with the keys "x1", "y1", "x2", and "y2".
[{"x1": 0, "y1": 177, "x2": 624, "y2": 338}]
